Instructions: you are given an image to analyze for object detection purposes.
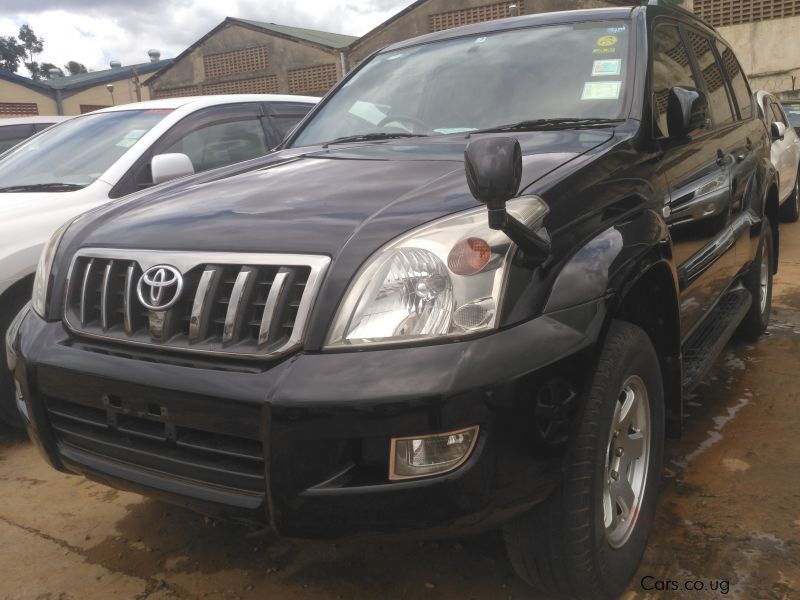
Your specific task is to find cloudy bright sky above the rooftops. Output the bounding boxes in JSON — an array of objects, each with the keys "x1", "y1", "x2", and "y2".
[{"x1": 0, "y1": 0, "x2": 413, "y2": 75}]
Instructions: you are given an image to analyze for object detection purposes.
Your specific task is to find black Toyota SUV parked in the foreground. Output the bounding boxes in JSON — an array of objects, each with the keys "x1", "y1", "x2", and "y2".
[{"x1": 8, "y1": 6, "x2": 778, "y2": 597}]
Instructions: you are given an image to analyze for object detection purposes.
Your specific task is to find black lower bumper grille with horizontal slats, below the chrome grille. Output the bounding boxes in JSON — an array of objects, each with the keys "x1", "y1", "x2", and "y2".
[{"x1": 45, "y1": 397, "x2": 265, "y2": 493}]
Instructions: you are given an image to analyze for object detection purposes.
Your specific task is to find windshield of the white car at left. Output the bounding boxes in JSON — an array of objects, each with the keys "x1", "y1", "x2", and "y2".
[{"x1": 0, "y1": 110, "x2": 171, "y2": 192}]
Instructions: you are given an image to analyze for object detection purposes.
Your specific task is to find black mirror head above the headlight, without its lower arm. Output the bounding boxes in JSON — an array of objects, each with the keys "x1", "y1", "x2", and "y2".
[{"x1": 464, "y1": 137, "x2": 522, "y2": 229}]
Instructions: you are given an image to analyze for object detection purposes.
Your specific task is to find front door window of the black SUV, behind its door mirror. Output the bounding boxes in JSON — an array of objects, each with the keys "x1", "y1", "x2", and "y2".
[{"x1": 651, "y1": 24, "x2": 699, "y2": 136}]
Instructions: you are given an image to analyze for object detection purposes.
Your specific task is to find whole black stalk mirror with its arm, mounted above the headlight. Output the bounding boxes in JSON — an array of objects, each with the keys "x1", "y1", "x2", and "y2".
[{"x1": 464, "y1": 137, "x2": 550, "y2": 263}]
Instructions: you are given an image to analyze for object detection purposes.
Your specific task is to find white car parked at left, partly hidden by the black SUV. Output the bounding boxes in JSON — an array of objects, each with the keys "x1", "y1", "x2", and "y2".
[{"x1": 0, "y1": 94, "x2": 318, "y2": 424}]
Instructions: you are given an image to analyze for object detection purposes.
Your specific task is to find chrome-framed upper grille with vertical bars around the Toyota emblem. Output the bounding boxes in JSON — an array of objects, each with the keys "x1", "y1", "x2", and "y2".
[{"x1": 64, "y1": 249, "x2": 330, "y2": 358}]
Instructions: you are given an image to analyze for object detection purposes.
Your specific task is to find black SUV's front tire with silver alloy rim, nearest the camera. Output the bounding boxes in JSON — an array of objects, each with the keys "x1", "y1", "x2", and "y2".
[{"x1": 504, "y1": 321, "x2": 664, "y2": 599}]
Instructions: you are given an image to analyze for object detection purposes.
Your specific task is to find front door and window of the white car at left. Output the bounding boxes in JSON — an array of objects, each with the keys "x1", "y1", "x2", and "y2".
[{"x1": 111, "y1": 102, "x2": 271, "y2": 198}]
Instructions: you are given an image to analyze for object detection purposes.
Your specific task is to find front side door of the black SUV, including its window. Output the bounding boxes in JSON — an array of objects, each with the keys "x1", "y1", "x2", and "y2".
[{"x1": 651, "y1": 21, "x2": 733, "y2": 337}]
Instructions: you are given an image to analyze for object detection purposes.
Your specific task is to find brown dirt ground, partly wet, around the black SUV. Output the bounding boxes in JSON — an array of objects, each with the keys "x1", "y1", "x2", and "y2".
[{"x1": 0, "y1": 224, "x2": 800, "y2": 600}]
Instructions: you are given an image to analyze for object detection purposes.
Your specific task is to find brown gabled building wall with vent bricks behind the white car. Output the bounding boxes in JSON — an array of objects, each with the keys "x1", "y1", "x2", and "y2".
[{"x1": 150, "y1": 23, "x2": 342, "y2": 98}]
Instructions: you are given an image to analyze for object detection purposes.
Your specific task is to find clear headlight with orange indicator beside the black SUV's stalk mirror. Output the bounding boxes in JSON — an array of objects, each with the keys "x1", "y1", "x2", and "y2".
[{"x1": 327, "y1": 196, "x2": 548, "y2": 347}]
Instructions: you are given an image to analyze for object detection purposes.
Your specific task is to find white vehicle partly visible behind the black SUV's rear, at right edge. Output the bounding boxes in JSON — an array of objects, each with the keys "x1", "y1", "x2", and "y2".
[{"x1": 756, "y1": 91, "x2": 800, "y2": 223}]
